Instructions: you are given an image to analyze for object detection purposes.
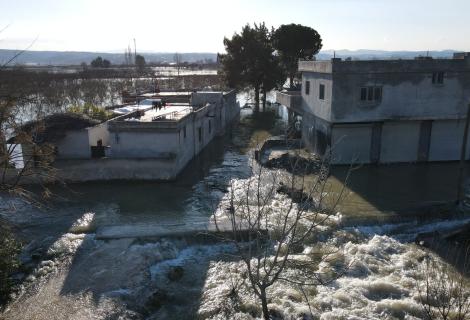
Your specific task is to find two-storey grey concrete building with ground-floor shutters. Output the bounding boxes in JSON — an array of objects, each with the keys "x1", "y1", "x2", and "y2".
[{"x1": 277, "y1": 53, "x2": 470, "y2": 164}]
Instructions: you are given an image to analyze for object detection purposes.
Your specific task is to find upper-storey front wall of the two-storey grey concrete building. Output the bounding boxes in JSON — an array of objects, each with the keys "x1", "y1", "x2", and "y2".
[{"x1": 331, "y1": 70, "x2": 470, "y2": 122}]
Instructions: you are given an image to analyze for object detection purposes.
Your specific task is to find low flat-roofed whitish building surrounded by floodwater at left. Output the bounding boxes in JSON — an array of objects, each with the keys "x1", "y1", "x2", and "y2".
[{"x1": 11, "y1": 91, "x2": 240, "y2": 182}]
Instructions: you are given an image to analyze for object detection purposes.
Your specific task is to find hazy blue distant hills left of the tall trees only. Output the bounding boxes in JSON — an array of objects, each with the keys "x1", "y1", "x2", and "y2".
[{"x1": 0, "y1": 49, "x2": 217, "y2": 66}]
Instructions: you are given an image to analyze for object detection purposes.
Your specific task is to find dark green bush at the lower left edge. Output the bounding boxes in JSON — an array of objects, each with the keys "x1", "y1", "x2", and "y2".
[{"x1": 0, "y1": 225, "x2": 20, "y2": 308}]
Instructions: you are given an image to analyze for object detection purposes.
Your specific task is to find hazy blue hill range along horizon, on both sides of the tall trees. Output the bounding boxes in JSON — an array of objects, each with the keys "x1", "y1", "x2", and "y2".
[{"x1": 0, "y1": 49, "x2": 457, "y2": 66}]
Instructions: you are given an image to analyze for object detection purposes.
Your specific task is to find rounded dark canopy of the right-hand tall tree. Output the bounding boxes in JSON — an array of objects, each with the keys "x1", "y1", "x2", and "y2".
[{"x1": 272, "y1": 24, "x2": 322, "y2": 87}]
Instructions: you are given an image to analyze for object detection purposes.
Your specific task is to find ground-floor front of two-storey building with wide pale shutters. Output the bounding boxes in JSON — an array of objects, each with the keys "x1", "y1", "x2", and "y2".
[{"x1": 331, "y1": 120, "x2": 470, "y2": 164}]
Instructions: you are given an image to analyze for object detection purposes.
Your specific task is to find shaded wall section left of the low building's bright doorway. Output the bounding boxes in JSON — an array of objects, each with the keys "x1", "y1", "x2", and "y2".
[{"x1": 56, "y1": 129, "x2": 91, "y2": 159}]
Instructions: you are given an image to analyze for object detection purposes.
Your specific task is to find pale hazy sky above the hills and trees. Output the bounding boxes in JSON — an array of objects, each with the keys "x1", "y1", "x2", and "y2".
[{"x1": 0, "y1": 0, "x2": 470, "y2": 52}]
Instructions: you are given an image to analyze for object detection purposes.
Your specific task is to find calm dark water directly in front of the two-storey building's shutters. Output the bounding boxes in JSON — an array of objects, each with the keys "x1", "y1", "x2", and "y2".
[{"x1": 330, "y1": 162, "x2": 470, "y2": 221}]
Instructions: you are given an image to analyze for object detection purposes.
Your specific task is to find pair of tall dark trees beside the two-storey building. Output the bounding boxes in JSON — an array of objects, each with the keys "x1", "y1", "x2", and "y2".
[{"x1": 220, "y1": 23, "x2": 322, "y2": 113}]
